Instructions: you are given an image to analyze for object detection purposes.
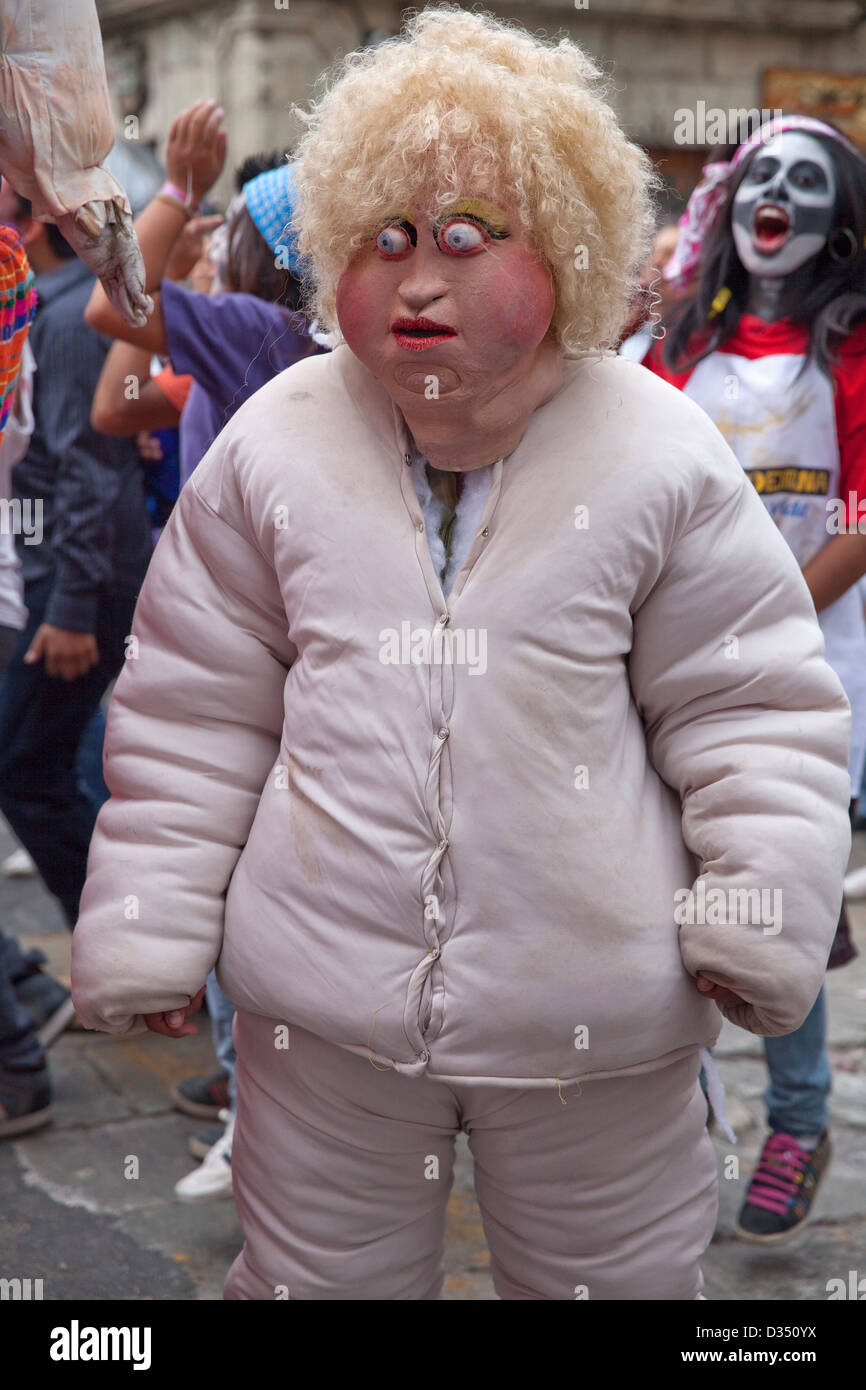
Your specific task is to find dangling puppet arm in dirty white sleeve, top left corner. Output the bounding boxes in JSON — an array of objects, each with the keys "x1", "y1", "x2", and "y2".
[{"x1": 0, "y1": 0, "x2": 153, "y2": 325}]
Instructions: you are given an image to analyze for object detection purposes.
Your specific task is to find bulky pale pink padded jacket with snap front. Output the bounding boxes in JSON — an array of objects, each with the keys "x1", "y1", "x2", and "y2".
[{"x1": 72, "y1": 346, "x2": 849, "y2": 1086}]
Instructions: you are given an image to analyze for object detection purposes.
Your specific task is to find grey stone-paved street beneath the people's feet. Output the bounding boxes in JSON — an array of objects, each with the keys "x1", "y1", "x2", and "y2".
[{"x1": 0, "y1": 833, "x2": 866, "y2": 1301}]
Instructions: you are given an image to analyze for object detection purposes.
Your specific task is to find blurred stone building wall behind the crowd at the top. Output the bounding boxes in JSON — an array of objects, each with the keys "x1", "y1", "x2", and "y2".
[{"x1": 97, "y1": 0, "x2": 866, "y2": 199}]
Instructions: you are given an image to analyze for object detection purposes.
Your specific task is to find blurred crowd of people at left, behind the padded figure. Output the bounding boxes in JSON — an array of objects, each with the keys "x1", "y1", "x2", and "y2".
[{"x1": 0, "y1": 100, "x2": 335, "y2": 1200}]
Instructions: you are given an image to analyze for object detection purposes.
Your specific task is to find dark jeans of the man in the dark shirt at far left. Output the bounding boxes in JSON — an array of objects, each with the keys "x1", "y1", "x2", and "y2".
[{"x1": 0, "y1": 575, "x2": 136, "y2": 927}]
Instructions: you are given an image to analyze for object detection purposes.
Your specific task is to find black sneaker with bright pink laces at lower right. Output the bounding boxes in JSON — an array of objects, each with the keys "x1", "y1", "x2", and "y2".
[{"x1": 734, "y1": 1130, "x2": 831, "y2": 1245}]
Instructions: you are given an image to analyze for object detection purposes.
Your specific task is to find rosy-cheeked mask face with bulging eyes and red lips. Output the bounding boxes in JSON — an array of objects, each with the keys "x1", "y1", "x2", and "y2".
[{"x1": 336, "y1": 197, "x2": 556, "y2": 410}]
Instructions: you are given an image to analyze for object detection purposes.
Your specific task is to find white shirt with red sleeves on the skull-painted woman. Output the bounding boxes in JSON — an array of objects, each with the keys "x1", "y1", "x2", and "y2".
[{"x1": 644, "y1": 314, "x2": 866, "y2": 795}]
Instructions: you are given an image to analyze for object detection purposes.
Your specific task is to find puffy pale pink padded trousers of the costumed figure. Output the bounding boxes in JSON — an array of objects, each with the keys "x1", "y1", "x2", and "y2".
[{"x1": 225, "y1": 1009, "x2": 717, "y2": 1301}]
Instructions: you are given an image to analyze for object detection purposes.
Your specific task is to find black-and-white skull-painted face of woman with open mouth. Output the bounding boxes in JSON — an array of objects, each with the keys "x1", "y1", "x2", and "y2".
[{"x1": 731, "y1": 131, "x2": 837, "y2": 275}]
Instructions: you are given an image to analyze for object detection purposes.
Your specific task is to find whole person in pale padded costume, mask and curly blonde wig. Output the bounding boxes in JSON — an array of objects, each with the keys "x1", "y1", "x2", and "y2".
[{"x1": 74, "y1": 6, "x2": 849, "y2": 1300}]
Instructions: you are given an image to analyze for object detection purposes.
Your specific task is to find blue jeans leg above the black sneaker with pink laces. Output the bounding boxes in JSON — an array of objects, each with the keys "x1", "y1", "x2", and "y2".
[{"x1": 763, "y1": 988, "x2": 831, "y2": 1138}]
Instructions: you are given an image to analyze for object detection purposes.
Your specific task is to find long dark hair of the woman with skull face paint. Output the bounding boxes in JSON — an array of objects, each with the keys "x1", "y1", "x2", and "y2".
[{"x1": 662, "y1": 131, "x2": 866, "y2": 374}]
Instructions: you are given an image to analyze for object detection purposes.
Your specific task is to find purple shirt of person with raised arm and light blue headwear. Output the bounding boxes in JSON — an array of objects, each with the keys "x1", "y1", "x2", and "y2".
[{"x1": 160, "y1": 279, "x2": 327, "y2": 487}]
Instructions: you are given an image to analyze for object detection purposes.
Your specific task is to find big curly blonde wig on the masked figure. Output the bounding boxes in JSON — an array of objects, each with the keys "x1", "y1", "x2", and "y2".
[{"x1": 292, "y1": 4, "x2": 657, "y2": 357}]
